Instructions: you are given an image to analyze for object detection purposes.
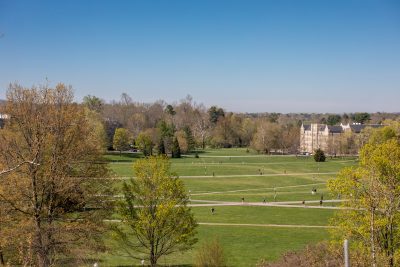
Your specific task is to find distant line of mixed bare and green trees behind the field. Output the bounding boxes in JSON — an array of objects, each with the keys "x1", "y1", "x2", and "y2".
[{"x1": 83, "y1": 93, "x2": 399, "y2": 156}]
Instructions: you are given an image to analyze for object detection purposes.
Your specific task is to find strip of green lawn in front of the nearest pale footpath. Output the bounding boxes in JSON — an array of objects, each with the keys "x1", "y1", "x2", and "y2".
[{"x1": 99, "y1": 225, "x2": 328, "y2": 267}]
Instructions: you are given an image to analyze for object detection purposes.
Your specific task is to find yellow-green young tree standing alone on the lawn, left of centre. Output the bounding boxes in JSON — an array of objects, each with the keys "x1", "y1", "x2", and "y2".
[{"x1": 114, "y1": 157, "x2": 197, "y2": 266}]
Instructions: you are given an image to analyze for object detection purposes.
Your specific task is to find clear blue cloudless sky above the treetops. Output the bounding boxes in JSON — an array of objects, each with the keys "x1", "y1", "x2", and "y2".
[{"x1": 0, "y1": 0, "x2": 400, "y2": 113}]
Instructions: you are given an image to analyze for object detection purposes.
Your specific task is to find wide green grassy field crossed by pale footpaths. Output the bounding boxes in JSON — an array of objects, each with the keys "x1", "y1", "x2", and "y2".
[{"x1": 99, "y1": 149, "x2": 357, "y2": 266}]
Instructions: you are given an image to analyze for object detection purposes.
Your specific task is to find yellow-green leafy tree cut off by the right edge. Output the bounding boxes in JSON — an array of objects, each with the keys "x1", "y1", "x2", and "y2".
[{"x1": 328, "y1": 138, "x2": 400, "y2": 266}]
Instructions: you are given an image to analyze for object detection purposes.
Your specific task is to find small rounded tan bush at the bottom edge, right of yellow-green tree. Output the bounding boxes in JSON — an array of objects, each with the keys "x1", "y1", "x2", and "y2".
[{"x1": 195, "y1": 239, "x2": 227, "y2": 267}]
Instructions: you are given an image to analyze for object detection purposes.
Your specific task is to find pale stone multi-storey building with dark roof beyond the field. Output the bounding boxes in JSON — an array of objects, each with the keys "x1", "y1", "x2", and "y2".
[{"x1": 300, "y1": 123, "x2": 382, "y2": 153}]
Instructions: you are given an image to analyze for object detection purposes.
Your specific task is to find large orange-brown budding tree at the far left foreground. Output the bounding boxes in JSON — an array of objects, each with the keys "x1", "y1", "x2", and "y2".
[{"x1": 0, "y1": 84, "x2": 111, "y2": 266}]
